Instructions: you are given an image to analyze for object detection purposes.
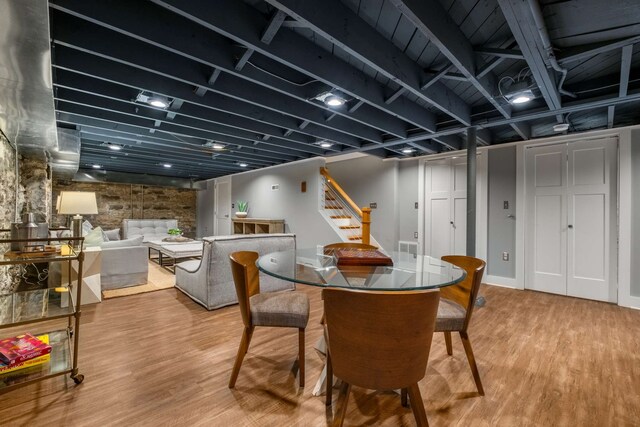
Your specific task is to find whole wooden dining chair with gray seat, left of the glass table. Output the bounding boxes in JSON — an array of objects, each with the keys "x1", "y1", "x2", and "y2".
[{"x1": 229, "y1": 251, "x2": 309, "y2": 388}]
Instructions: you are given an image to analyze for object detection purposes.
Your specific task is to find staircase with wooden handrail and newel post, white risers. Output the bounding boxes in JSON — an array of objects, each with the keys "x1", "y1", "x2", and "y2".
[{"x1": 320, "y1": 168, "x2": 380, "y2": 247}]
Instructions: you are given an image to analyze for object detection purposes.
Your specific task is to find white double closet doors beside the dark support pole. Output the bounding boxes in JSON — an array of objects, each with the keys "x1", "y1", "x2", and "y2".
[{"x1": 424, "y1": 157, "x2": 467, "y2": 258}]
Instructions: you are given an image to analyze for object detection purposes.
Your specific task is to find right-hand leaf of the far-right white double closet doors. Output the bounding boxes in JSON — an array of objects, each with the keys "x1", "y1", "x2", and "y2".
[{"x1": 567, "y1": 139, "x2": 617, "y2": 302}]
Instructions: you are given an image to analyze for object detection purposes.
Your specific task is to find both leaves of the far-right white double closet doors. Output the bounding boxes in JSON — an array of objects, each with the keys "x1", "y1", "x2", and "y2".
[{"x1": 525, "y1": 138, "x2": 617, "y2": 302}]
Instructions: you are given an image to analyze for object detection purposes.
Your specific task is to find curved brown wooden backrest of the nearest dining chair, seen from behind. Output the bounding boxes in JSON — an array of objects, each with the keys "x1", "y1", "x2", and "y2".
[{"x1": 322, "y1": 288, "x2": 440, "y2": 390}]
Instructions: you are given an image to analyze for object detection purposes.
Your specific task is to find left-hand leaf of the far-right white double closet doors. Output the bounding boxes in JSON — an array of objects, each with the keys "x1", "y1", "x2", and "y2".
[{"x1": 525, "y1": 144, "x2": 567, "y2": 295}]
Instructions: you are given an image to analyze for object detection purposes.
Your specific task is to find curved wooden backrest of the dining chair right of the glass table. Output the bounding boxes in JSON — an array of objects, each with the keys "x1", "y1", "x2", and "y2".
[{"x1": 440, "y1": 255, "x2": 487, "y2": 330}]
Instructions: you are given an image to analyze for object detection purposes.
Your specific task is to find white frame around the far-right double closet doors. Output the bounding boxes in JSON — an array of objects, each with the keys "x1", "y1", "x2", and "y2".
[{"x1": 514, "y1": 137, "x2": 623, "y2": 298}]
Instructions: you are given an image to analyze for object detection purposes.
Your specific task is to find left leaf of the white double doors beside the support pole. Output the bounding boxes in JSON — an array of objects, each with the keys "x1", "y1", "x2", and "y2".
[{"x1": 424, "y1": 160, "x2": 452, "y2": 258}]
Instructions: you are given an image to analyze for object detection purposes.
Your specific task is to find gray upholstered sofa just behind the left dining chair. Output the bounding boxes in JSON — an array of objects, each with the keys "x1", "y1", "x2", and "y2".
[{"x1": 176, "y1": 234, "x2": 296, "y2": 310}]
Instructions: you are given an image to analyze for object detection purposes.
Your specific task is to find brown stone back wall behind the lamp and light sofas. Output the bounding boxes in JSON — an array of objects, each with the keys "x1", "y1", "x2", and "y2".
[{"x1": 51, "y1": 179, "x2": 196, "y2": 235}]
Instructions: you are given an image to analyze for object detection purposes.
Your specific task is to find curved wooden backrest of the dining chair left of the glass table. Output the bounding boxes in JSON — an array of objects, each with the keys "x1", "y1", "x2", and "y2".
[{"x1": 229, "y1": 251, "x2": 260, "y2": 327}]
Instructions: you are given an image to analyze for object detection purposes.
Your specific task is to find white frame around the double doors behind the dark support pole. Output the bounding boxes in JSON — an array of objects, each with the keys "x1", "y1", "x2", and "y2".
[{"x1": 418, "y1": 147, "x2": 489, "y2": 259}]
